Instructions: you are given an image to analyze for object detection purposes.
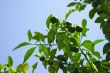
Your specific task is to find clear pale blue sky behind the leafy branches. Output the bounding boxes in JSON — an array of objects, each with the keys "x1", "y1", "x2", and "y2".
[{"x1": 0, "y1": 0, "x2": 105, "y2": 73}]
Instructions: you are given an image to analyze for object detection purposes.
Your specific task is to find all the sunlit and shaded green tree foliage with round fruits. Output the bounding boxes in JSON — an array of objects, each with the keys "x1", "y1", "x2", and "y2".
[{"x1": 0, "y1": 0, "x2": 110, "y2": 73}]
